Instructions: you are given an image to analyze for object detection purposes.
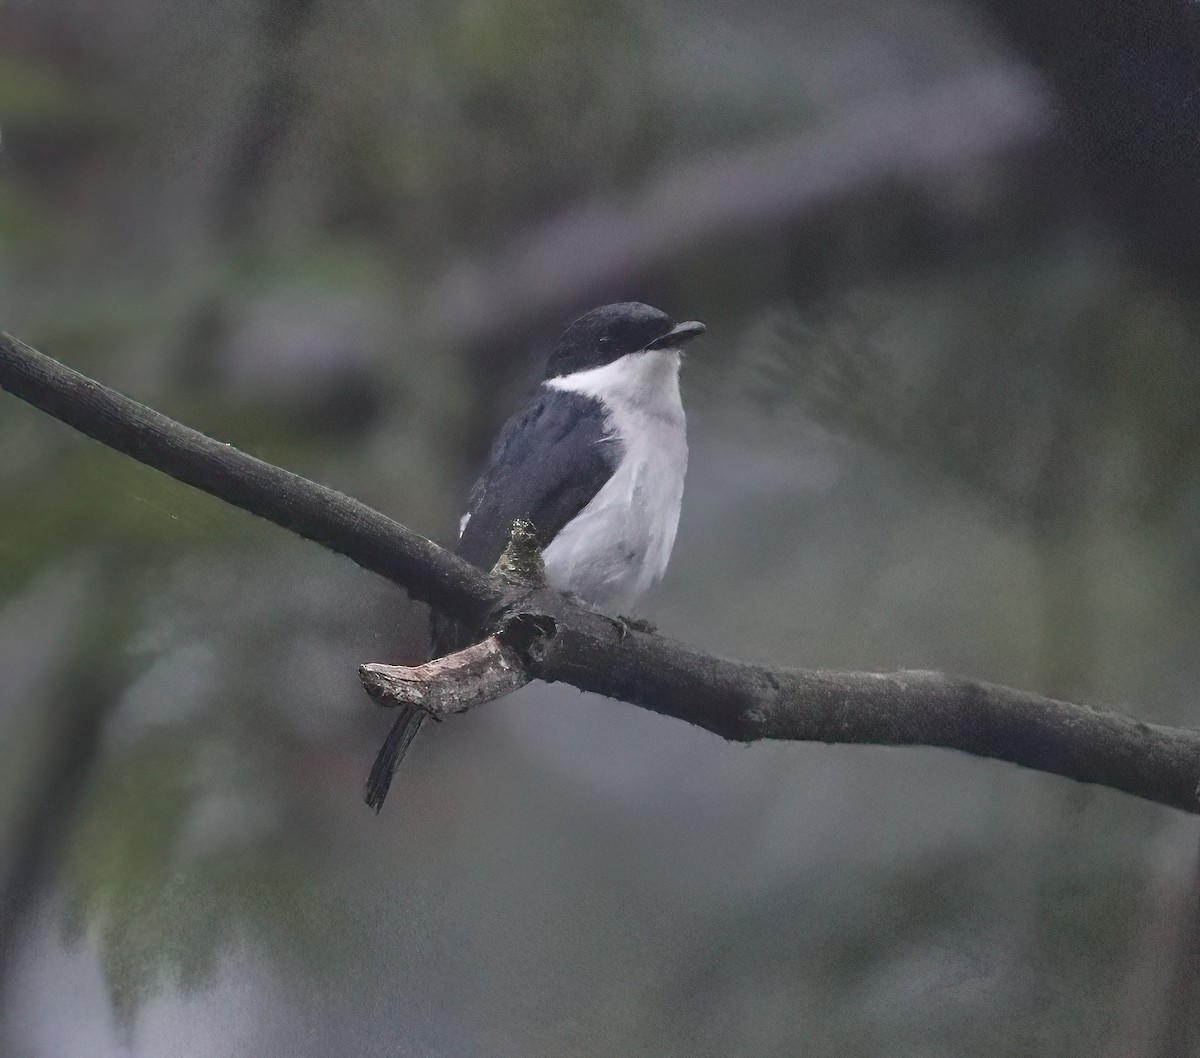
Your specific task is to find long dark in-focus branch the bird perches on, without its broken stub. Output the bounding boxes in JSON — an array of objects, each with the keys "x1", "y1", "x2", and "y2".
[{"x1": 0, "y1": 335, "x2": 1200, "y2": 812}]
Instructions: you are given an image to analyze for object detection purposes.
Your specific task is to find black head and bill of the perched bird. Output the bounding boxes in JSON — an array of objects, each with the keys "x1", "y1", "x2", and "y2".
[{"x1": 546, "y1": 301, "x2": 704, "y2": 379}]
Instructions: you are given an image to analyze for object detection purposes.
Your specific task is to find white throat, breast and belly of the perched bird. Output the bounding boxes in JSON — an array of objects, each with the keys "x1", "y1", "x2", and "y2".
[{"x1": 544, "y1": 349, "x2": 688, "y2": 612}]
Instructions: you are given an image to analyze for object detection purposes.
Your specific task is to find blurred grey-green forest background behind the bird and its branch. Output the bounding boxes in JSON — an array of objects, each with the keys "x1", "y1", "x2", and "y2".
[{"x1": 0, "y1": 0, "x2": 1200, "y2": 1058}]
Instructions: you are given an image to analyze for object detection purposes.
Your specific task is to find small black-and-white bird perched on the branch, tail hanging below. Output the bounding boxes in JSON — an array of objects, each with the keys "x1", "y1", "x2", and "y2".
[{"x1": 364, "y1": 301, "x2": 704, "y2": 812}]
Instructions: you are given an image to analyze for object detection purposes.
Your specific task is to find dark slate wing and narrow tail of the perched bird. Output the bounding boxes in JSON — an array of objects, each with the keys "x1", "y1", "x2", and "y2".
[{"x1": 364, "y1": 386, "x2": 620, "y2": 812}]
